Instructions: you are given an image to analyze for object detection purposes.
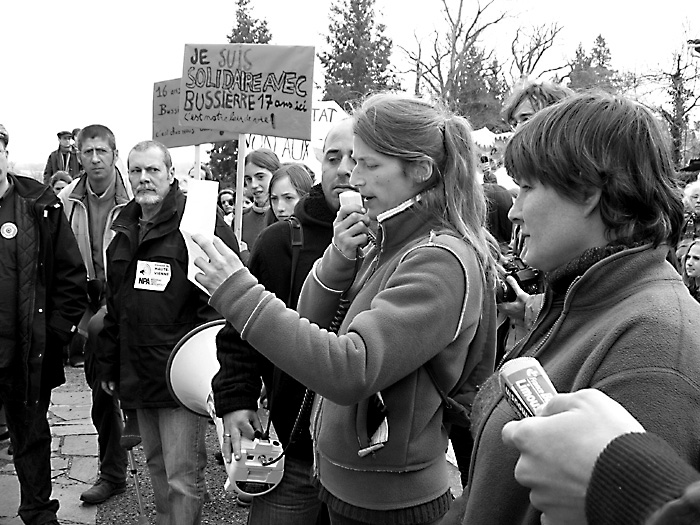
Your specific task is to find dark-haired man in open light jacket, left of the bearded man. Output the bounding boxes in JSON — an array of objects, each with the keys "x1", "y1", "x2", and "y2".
[{"x1": 59, "y1": 124, "x2": 133, "y2": 504}]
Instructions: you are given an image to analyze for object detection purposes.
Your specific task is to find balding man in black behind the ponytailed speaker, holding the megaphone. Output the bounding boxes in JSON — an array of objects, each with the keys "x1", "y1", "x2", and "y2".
[{"x1": 212, "y1": 120, "x2": 355, "y2": 525}]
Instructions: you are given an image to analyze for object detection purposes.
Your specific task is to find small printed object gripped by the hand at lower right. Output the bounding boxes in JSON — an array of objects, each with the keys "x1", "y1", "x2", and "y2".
[{"x1": 499, "y1": 357, "x2": 557, "y2": 417}]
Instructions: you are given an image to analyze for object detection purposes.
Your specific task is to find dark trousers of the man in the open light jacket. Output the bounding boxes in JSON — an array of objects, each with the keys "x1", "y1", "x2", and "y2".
[{"x1": 85, "y1": 307, "x2": 128, "y2": 484}]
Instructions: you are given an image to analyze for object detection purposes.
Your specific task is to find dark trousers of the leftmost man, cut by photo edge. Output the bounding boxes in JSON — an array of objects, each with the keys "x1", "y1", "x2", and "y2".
[{"x1": 0, "y1": 368, "x2": 58, "y2": 525}]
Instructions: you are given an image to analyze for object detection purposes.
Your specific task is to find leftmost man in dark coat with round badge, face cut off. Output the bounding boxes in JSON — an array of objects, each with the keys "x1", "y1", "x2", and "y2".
[{"x1": 0, "y1": 125, "x2": 87, "y2": 524}]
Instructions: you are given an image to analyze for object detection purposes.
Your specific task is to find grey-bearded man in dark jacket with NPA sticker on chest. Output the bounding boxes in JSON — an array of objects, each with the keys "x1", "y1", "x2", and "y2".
[{"x1": 96, "y1": 141, "x2": 238, "y2": 525}]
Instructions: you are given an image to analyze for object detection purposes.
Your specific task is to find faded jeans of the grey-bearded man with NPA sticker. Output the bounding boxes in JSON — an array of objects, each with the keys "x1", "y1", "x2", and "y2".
[{"x1": 136, "y1": 408, "x2": 207, "y2": 525}]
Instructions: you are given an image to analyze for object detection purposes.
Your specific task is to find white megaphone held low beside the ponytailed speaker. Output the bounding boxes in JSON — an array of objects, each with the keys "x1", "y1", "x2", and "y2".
[{"x1": 165, "y1": 319, "x2": 284, "y2": 496}]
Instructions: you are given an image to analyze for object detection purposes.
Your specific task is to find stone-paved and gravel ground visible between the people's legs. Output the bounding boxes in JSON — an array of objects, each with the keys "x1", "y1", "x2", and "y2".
[{"x1": 0, "y1": 367, "x2": 462, "y2": 525}]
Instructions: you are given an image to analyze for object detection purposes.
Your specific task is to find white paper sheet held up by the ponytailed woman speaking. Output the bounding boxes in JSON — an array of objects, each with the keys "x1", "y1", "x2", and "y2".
[{"x1": 180, "y1": 179, "x2": 219, "y2": 294}]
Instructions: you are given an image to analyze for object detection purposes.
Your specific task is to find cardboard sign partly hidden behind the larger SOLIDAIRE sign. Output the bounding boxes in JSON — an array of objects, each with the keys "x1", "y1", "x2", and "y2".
[{"x1": 153, "y1": 78, "x2": 238, "y2": 148}]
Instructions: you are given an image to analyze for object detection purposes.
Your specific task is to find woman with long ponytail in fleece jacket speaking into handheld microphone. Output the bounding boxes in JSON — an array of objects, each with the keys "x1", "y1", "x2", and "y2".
[{"x1": 195, "y1": 94, "x2": 495, "y2": 525}]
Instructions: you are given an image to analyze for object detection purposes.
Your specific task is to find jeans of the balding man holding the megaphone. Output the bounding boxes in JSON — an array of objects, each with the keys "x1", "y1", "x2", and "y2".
[{"x1": 248, "y1": 456, "x2": 329, "y2": 525}]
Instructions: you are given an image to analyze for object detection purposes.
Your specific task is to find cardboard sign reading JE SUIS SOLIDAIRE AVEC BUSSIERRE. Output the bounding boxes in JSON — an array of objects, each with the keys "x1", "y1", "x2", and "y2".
[{"x1": 178, "y1": 44, "x2": 314, "y2": 140}]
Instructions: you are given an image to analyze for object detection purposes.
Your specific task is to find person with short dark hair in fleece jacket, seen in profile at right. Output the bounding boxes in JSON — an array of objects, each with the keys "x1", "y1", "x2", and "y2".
[{"x1": 444, "y1": 94, "x2": 700, "y2": 525}]
